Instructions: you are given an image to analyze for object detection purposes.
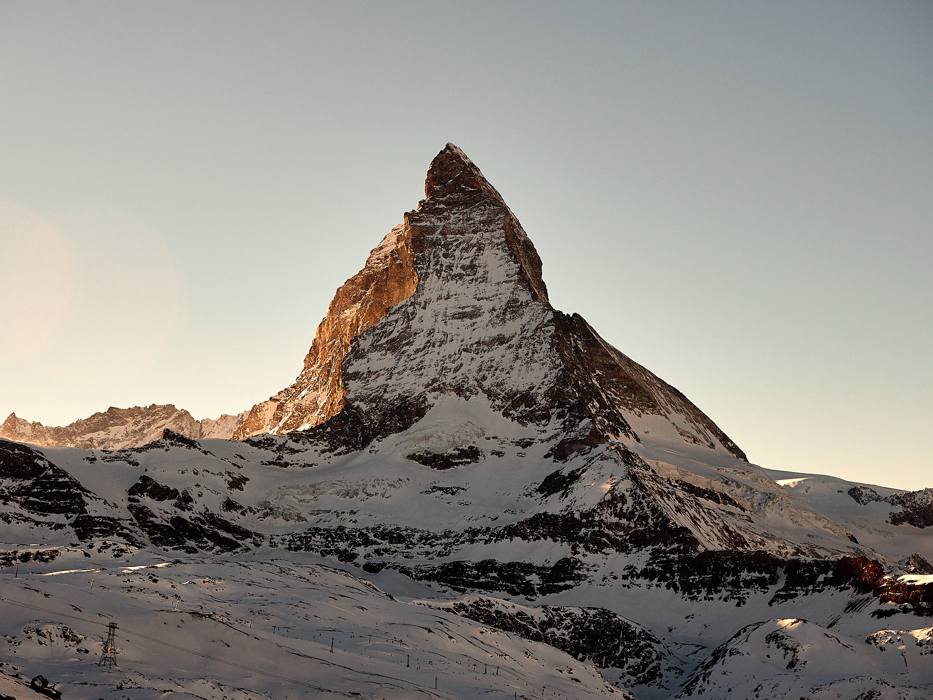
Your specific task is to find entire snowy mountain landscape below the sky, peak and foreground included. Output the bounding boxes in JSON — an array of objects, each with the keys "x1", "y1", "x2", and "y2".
[{"x1": 0, "y1": 144, "x2": 933, "y2": 700}]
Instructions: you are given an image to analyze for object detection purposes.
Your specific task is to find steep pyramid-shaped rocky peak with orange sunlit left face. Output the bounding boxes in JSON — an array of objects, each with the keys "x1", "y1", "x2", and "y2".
[{"x1": 235, "y1": 144, "x2": 745, "y2": 460}]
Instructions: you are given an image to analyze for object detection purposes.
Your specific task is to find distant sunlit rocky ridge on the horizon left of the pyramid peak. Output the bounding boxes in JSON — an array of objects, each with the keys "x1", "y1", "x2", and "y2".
[{"x1": 0, "y1": 404, "x2": 244, "y2": 450}]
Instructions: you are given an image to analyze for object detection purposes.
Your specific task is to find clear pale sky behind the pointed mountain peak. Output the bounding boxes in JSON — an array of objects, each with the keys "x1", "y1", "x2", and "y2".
[{"x1": 0, "y1": 0, "x2": 933, "y2": 488}]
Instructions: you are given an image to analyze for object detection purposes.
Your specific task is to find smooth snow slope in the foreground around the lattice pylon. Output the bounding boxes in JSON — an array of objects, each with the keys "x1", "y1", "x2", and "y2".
[{"x1": 0, "y1": 558, "x2": 627, "y2": 700}]
